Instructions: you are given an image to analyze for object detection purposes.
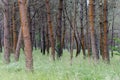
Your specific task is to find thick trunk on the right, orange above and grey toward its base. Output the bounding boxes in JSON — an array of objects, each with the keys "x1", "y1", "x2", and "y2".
[{"x1": 89, "y1": 0, "x2": 98, "y2": 61}]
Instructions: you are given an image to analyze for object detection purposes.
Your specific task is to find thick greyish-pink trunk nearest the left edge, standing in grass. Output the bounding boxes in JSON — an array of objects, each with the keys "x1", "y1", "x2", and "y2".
[{"x1": 3, "y1": 0, "x2": 10, "y2": 64}]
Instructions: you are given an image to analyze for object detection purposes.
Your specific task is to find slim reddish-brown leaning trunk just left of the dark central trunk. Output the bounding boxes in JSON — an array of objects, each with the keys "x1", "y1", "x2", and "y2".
[{"x1": 45, "y1": 0, "x2": 55, "y2": 60}]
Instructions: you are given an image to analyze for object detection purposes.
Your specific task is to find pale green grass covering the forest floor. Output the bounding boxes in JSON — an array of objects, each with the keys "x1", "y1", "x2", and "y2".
[{"x1": 0, "y1": 50, "x2": 120, "y2": 80}]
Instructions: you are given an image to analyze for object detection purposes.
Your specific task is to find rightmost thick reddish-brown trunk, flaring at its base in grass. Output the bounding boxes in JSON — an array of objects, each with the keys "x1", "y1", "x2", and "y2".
[{"x1": 103, "y1": 0, "x2": 110, "y2": 62}]
